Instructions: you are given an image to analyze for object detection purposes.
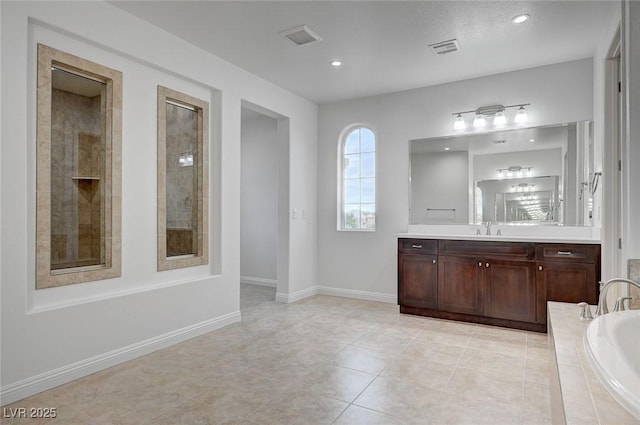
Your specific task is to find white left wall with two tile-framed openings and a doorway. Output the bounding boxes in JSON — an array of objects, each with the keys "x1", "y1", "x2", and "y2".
[{"x1": 0, "y1": 2, "x2": 317, "y2": 403}]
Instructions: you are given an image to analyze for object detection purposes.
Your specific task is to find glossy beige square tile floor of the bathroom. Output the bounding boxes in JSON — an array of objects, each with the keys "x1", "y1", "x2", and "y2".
[{"x1": 2, "y1": 285, "x2": 551, "y2": 425}]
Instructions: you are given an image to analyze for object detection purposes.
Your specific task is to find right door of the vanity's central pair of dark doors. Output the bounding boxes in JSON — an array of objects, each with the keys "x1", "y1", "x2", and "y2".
[{"x1": 484, "y1": 260, "x2": 536, "y2": 322}]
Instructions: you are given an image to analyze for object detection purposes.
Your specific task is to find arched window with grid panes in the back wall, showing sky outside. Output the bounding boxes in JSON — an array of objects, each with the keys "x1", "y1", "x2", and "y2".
[{"x1": 338, "y1": 127, "x2": 376, "y2": 230}]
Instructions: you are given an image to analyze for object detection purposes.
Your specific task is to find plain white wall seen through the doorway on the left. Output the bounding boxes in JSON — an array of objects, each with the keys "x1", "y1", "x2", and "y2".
[{"x1": 240, "y1": 108, "x2": 278, "y2": 286}]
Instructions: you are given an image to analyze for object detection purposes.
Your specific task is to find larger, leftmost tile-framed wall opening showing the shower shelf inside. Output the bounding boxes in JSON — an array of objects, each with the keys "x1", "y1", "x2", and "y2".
[{"x1": 36, "y1": 44, "x2": 122, "y2": 289}]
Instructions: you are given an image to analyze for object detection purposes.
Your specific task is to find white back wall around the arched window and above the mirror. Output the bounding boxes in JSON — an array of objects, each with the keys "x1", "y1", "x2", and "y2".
[{"x1": 318, "y1": 59, "x2": 593, "y2": 301}]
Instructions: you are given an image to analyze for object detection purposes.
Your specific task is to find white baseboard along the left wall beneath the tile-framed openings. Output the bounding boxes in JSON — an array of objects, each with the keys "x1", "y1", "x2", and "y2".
[{"x1": 0, "y1": 311, "x2": 241, "y2": 405}]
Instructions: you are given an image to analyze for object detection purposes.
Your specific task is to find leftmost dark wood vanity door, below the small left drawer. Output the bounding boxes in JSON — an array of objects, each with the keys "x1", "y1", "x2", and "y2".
[{"x1": 398, "y1": 254, "x2": 438, "y2": 310}]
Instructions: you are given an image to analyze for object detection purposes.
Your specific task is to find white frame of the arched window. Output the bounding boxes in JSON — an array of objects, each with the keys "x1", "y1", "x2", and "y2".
[{"x1": 337, "y1": 124, "x2": 378, "y2": 232}]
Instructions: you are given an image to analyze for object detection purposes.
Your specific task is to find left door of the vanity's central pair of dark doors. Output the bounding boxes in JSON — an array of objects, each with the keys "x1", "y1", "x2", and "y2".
[{"x1": 438, "y1": 255, "x2": 484, "y2": 315}]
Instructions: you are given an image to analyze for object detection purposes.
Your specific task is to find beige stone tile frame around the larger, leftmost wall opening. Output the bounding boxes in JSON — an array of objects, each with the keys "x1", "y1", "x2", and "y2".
[{"x1": 35, "y1": 43, "x2": 122, "y2": 290}]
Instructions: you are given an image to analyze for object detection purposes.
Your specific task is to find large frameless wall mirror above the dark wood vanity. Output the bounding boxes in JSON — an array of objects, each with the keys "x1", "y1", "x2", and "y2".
[{"x1": 409, "y1": 121, "x2": 599, "y2": 226}]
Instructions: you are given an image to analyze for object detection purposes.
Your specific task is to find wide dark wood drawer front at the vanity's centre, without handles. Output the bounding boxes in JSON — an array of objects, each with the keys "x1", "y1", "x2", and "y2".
[{"x1": 439, "y1": 240, "x2": 535, "y2": 260}]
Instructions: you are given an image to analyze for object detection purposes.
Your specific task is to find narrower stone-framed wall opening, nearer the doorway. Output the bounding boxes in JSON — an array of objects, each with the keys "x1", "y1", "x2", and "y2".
[{"x1": 158, "y1": 86, "x2": 209, "y2": 270}]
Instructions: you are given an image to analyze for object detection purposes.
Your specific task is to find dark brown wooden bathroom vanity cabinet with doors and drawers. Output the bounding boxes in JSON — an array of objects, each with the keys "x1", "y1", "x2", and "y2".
[{"x1": 398, "y1": 236, "x2": 600, "y2": 332}]
